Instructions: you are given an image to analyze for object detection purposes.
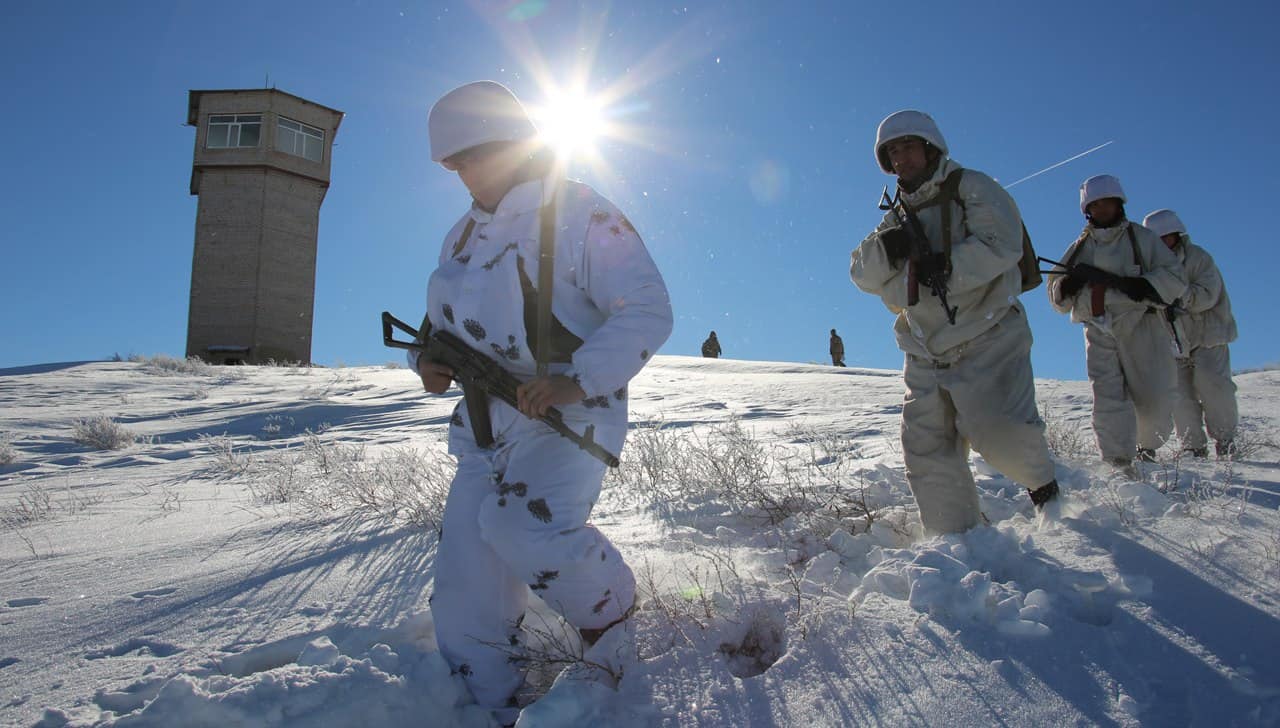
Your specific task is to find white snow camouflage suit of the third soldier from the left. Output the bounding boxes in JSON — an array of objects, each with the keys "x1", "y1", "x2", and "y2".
[{"x1": 1046, "y1": 220, "x2": 1187, "y2": 463}]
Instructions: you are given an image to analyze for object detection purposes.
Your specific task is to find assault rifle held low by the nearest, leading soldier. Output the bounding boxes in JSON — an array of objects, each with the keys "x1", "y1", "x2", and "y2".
[{"x1": 383, "y1": 311, "x2": 618, "y2": 467}]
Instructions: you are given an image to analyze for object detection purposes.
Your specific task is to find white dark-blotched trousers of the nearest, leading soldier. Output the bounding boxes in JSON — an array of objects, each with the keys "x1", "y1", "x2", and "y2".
[{"x1": 431, "y1": 420, "x2": 635, "y2": 708}]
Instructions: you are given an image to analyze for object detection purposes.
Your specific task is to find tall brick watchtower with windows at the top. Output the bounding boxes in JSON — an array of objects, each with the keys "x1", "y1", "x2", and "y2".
[{"x1": 187, "y1": 88, "x2": 342, "y2": 363}]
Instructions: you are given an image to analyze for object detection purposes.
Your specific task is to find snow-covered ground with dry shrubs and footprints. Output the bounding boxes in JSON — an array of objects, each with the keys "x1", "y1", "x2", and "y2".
[{"x1": 0, "y1": 357, "x2": 1280, "y2": 728}]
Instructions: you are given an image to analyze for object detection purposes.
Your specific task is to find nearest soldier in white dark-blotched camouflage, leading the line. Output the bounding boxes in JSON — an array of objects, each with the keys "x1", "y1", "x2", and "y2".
[{"x1": 410, "y1": 81, "x2": 672, "y2": 724}]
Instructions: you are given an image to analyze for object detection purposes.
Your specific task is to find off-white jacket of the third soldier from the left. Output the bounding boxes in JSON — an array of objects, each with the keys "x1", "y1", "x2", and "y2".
[{"x1": 1046, "y1": 220, "x2": 1187, "y2": 335}]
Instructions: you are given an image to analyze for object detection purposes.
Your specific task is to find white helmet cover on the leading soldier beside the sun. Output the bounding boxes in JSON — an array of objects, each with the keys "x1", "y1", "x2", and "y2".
[{"x1": 426, "y1": 81, "x2": 538, "y2": 162}]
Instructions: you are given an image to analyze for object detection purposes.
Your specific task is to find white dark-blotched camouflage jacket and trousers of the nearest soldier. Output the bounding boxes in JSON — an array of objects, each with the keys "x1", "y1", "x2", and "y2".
[{"x1": 410, "y1": 180, "x2": 672, "y2": 708}]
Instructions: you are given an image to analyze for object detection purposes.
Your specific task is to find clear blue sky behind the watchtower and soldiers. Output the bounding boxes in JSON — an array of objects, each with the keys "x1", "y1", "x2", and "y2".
[{"x1": 0, "y1": 0, "x2": 1280, "y2": 379}]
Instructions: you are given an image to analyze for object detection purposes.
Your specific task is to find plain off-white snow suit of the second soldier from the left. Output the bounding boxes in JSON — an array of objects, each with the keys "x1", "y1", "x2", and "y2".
[{"x1": 850, "y1": 159, "x2": 1053, "y2": 534}]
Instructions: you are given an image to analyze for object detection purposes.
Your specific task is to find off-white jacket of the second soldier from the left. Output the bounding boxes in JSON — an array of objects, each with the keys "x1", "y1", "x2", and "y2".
[{"x1": 849, "y1": 159, "x2": 1023, "y2": 360}]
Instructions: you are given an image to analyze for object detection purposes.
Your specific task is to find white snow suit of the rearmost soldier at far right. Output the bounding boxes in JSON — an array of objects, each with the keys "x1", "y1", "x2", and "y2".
[{"x1": 1174, "y1": 233, "x2": 1239, "y2": 449}]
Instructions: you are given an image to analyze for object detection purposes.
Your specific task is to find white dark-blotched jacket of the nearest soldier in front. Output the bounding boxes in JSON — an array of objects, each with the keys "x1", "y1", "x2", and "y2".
[{"x1": 410, "y1": 180, "x2": 672, "y2": 409}]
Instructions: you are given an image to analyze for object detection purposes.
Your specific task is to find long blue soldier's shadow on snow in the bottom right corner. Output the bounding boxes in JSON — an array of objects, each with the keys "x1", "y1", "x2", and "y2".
[{"x1": 941, "y1": 518, "x2": 1280, "y2": 725}]
